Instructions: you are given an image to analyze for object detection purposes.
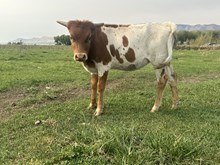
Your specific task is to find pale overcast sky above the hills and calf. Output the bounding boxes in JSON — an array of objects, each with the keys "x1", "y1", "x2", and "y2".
[{"x1": 0, "y1": 0, "x2": 220, "y2": 43}]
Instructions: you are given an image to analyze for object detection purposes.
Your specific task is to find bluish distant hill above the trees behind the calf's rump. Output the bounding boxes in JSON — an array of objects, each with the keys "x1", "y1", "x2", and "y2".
[{"x1": 177, "y1": 24, "x2": 220, "y2": 31}]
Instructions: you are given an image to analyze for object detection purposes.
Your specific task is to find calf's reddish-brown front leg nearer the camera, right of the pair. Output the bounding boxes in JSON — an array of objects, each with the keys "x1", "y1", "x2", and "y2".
[{"x1": 95, "y1": 72, "x2": 108, "y2": 116}]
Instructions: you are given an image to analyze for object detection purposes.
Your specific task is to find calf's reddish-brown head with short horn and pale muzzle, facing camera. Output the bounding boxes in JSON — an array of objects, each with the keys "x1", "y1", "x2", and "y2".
[{"x1": 57, "y1": 21, "x2": 103, "y2": 62}]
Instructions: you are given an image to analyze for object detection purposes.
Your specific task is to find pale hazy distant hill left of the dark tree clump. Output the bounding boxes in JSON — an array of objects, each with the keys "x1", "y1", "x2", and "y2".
[{"x1": 10, "y1": 37, "x2": 55, "y2": 45}]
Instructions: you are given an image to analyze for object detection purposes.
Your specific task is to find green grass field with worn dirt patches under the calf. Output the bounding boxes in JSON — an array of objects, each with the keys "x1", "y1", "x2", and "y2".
[{"x1": 0, "y1": 46, "x2": 220, "y2": 165}]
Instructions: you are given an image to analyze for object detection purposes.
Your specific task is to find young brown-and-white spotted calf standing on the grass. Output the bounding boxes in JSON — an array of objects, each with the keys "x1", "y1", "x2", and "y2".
[{"x1": 57, "y1": 20, "x2": 178, "y2": 116}]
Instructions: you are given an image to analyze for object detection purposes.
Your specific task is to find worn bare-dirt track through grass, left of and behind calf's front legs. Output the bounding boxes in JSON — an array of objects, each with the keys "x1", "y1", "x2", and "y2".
[{"x1": 0, "y1": 79, "x2": 125, "y2": 118}]
